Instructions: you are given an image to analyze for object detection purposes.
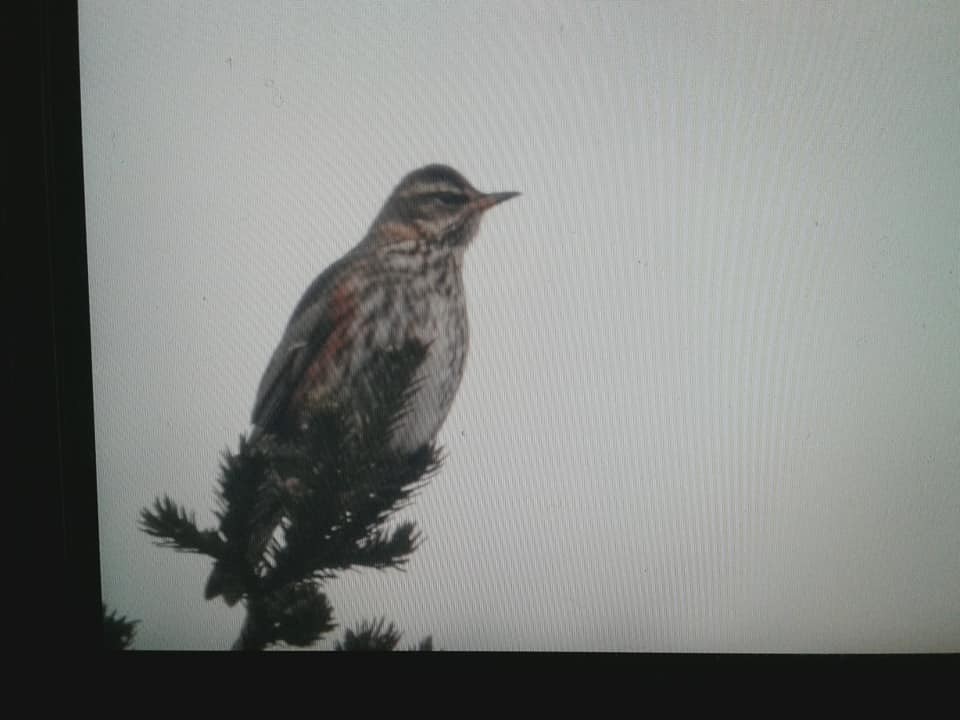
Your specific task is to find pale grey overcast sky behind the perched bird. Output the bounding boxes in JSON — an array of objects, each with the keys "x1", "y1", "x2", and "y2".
[{"x1": 80, "y1": 0, "x2": 960, "y2": 651}]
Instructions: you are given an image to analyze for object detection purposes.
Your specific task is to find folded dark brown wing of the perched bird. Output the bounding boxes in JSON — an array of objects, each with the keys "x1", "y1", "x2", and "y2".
[{"x1": 251, "y1": 257, "x2": 360, "y2": 431}]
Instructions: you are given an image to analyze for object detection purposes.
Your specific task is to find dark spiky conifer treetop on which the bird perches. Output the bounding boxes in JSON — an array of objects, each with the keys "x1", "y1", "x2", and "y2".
[{"x1": 141, "y1": 344, "x2": 442, "y2": 650}]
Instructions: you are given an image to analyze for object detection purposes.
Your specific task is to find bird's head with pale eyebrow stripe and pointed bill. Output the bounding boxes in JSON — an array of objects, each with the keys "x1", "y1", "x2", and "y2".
[{"x1": 374, "y1": 165, "x2": 520, "y2": 248}]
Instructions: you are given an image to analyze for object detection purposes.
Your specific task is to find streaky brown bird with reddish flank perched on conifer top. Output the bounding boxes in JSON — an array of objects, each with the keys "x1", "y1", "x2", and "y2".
[{"x1": 205, "y1": 164, "x2": 520, "y2": 604}]
